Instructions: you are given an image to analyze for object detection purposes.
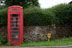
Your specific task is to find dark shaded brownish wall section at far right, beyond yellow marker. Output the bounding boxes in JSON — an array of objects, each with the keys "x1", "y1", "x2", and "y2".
[{"x1": 56, "y1": 25, "x2": 72, "y2": 38}]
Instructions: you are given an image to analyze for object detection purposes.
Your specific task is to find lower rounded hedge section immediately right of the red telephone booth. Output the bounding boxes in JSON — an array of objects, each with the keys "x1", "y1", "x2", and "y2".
[{"x1": 24, "y1": 8, "x2": 55, "y2": 26}]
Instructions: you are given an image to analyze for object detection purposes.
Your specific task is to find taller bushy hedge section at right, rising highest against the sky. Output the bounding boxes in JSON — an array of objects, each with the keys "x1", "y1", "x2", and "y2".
[{"x1": 51, "y1": 4, "x2": 72, "y2": 24}]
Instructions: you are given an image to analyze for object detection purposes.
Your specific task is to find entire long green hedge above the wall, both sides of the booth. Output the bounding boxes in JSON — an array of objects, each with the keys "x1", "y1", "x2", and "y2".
[{"x1": 0, "y1": 4, "x2": 72, "y2": 26}]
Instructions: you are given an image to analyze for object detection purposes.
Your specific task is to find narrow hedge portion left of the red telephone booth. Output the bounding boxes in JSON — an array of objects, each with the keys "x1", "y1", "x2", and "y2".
[{"x1": 0, "y1": 8, "x2": 7, "y2": 24}]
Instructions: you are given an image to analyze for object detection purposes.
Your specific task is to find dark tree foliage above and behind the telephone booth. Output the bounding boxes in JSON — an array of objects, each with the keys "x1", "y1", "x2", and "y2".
[{"x1": 6, "y1": 0, "x2": 39, "y2": 8}]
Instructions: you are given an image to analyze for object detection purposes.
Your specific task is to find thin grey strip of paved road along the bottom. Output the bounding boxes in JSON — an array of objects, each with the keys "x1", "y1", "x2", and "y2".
[{"x1": 0, "y1": 46, "x2": 72, "y2": 48}]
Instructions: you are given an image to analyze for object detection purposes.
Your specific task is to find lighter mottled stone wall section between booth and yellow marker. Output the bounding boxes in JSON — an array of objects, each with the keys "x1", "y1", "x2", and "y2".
[{"x1": 24, "y1": 26, "x2": 53, "y2": 42}]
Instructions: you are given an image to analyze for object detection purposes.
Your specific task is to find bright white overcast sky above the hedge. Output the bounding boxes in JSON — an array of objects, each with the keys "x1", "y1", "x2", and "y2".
[{"x1": 39, "y1": 0, "x2": 72, "y2": 8}]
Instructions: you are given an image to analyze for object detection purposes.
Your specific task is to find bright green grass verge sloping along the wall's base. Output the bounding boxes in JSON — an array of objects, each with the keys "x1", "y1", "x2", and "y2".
[{"x1": 20, "y1": 37, "x2": 72, "y2": 46}]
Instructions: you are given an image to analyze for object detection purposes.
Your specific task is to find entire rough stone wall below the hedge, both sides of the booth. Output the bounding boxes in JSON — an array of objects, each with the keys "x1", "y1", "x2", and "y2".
[{"x1": 0, "y1": 24, "x2": 72, "y2": 42}]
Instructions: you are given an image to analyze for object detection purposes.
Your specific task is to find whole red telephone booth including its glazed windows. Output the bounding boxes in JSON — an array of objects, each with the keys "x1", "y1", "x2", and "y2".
[{"x1": 8, "y1": 6, "x2": 23, "y2": 45}]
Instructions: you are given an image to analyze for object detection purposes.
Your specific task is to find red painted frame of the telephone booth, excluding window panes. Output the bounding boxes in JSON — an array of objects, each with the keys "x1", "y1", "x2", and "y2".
[{"x1": 8, "y1": 6, "x2": 23, "y2": 45}]
